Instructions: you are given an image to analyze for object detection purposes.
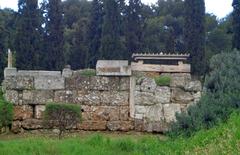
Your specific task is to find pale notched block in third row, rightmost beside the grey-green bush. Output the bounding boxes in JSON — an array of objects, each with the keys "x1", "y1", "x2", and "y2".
[{"x1": 163, "y1": 104, "x2": 181, "y2": 123}]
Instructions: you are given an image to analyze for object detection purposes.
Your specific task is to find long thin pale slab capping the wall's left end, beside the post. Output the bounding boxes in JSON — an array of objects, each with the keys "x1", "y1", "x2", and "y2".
[{"x1": 17, "y1": 70, "x2": 62, "y2": 77}]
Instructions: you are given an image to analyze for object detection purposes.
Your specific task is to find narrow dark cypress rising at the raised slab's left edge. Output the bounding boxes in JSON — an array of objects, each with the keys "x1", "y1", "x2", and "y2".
[{"x1": 88, "y1": 0, "x2": 103, "y2": 68}]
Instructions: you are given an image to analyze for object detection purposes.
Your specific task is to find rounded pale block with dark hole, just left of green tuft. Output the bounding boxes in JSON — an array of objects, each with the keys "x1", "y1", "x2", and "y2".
[{"x1": 140, "y1": 78, "x2": 157, "y2": 93}]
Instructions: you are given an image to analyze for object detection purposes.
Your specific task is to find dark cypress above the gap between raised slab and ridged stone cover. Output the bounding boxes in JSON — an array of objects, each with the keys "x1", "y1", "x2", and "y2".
[{"x1": 126, "y1": 0, "x2": 143, "y2": 59}]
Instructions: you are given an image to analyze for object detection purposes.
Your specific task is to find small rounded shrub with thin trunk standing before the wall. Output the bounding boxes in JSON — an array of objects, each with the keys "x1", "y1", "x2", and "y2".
[{"x1": 44, "y1": 103, "x2": 81, "y2": 139}]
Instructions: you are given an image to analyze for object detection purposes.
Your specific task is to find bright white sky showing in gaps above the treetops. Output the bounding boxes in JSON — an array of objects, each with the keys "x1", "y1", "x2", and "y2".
[{"x1": 0, "y1": 0, "x2": 232, "y2": 19}]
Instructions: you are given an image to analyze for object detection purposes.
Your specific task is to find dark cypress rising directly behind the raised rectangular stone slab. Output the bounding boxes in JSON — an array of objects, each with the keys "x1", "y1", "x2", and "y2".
[{"x1": 100, "y1": 0, "x2": 123, "y2": 59}]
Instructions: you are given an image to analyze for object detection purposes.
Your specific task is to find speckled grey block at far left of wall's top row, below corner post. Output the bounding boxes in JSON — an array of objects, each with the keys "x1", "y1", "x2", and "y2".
[{"x1": 3, "y1": 76, "x2": 33, "y2": 90}]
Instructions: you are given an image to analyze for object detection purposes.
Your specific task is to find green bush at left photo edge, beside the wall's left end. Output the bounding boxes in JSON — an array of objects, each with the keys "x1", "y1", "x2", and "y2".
[{"x1": 0, "y1": 87, "x2": 13, "y2": 133}]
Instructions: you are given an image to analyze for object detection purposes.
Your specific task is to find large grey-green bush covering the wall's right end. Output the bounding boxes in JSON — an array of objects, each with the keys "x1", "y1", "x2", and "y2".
[{"x1": 170, "y1": 50, "x2": 240, "y2": 136}]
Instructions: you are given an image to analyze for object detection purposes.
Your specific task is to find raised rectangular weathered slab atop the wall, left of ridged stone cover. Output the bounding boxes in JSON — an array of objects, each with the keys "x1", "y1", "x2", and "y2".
[{"x1": 96, "y1": 60, "x2": 132, "y2": 76}]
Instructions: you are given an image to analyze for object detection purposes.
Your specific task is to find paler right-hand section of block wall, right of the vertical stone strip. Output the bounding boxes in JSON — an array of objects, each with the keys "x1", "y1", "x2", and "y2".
[{"x1": 134, "y1": 73, "x2": 202, "y2": 132}]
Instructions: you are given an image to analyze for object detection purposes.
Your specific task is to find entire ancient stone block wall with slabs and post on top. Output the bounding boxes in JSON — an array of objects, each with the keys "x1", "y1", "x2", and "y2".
[{"x1": 3, "y1": 53, "x2": 202, "y2": 133}]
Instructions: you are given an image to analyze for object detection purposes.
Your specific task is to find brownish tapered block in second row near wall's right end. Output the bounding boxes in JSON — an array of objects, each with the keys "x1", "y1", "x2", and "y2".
[{"x1": 171, "y1": 88, "x2": 194, "y2": 104}]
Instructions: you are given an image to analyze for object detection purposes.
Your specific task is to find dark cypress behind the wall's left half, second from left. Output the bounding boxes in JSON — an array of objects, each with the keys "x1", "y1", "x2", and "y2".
[{"x1": 45, "y1": 0, "x2": 65, "y2": 70}]
